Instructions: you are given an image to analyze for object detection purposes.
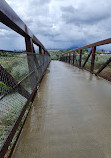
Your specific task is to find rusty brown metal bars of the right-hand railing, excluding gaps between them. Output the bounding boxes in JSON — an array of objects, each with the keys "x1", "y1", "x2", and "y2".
[{"x1": 60, "y1": 38, "x2": 111, "y2": 81}]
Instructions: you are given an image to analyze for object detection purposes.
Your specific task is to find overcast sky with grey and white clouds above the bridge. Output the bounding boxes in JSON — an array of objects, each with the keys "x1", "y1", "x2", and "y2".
[{"x1": 0, "y1": 0, "x2": 111, "y2": 50}]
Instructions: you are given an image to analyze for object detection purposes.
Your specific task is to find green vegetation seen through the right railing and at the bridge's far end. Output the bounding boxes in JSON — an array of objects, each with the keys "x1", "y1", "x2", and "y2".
[{"x1": 49, "y1": 49, "x2": 111, "y2": 77}]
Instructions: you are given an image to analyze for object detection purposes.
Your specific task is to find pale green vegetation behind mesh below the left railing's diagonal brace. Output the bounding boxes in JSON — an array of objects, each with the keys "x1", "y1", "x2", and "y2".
[{"x1": 0, "y1": 94, "x2": 32, "y2": 150}]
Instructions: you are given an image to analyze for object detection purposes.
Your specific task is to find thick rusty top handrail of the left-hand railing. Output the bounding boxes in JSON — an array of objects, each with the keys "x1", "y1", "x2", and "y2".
[{"x1": 0, "y1": 0, "x2": 50, "y2": 56}]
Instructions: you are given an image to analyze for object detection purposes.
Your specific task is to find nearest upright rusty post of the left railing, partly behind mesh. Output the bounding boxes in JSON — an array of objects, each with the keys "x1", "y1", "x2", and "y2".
[{"x1": 25, "y1": 38, "x2": 36, "y2": 90}]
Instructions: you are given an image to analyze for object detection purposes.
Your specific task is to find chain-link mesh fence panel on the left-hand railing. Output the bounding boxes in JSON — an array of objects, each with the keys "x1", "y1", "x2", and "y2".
[{"x1": 0, "y1": 52, "x2": 50, "y2": 157}]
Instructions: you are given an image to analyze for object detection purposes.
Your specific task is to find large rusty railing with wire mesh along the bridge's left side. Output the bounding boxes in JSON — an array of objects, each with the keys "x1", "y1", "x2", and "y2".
[{"x1": 0, "y1": 0, "x2": 51, "y2": 158}]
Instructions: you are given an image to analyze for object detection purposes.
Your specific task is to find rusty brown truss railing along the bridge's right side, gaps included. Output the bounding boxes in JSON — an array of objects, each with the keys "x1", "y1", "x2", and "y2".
[{"x1": 60, "y1": 38, "x2": 111, "y2": 81}]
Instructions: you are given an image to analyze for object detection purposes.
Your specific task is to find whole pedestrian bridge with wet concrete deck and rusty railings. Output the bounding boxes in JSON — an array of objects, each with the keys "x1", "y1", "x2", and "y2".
[{"x1": 0, "y1": 0, "x2": 111, "y2": 158}]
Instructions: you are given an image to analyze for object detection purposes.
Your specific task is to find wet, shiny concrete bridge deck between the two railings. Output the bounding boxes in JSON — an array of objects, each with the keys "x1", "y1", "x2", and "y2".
[{"x1": 12, "y1": 61, "x2": 111, "y2": 158}]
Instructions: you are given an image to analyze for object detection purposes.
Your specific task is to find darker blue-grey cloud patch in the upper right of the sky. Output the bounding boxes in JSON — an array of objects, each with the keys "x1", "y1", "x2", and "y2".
[{"x1": 61, "y1": 3, "x2": 111, "y2": 25}]
